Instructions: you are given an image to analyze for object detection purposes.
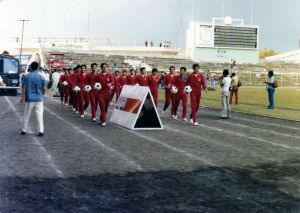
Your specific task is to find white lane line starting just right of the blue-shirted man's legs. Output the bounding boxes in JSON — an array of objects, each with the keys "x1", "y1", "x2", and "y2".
[{"x1": 44, "y1": 107, "x2": 144, "y2": 171}]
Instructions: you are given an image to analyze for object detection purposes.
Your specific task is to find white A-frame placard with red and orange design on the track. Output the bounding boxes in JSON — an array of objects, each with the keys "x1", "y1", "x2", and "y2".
[{"x1": 110, "y1": 85, "x2": 163, "y2": 130}]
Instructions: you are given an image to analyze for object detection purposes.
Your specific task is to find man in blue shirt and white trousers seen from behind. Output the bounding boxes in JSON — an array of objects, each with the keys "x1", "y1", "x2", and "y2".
[{"x1": 21, "y1": 62, "x2": 46, "y2": 136}]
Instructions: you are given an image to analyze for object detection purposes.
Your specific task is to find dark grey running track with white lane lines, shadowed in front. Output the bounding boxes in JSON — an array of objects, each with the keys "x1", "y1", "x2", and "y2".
[{"x1": 0, "y1": 96, "x2": 300, "y2": 213}]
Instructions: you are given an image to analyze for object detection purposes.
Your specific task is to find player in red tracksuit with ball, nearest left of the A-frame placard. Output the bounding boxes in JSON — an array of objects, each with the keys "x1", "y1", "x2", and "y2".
[{"x1": 95, "y1": 63, "x2": 114, "y2": 127}]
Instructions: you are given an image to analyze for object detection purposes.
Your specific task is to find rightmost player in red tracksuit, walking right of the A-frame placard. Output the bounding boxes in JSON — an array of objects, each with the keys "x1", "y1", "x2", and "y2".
[{"x1": 186, "y1": 64, "x2": 207, "y2": 126}]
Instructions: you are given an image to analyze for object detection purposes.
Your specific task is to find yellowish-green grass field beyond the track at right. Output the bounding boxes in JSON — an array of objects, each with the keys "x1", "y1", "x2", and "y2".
[{"x1": 159, "y1": 87, "x2": 300, "y2": 121}]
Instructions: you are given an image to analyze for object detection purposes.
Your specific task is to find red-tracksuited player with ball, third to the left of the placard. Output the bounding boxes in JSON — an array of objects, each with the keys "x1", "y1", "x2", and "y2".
[{"x1": 77, "y1": 64, "x2": 90, "y2": 118}]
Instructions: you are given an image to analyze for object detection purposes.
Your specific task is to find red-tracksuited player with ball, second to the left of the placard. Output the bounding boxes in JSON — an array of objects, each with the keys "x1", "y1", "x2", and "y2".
[{"x1": 86, "y1": 63, "x2": 98, "y2": 122}]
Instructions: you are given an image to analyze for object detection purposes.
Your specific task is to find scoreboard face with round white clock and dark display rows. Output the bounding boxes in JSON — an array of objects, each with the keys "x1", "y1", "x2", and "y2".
[{"x1": 196, "y1": 24, "x2": 258, "y2": 49}]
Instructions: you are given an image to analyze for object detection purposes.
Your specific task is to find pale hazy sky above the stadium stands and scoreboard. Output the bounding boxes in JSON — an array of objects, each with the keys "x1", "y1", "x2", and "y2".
[{"x1": 0, "y1": 0, "x2": 300, "y2": 52}]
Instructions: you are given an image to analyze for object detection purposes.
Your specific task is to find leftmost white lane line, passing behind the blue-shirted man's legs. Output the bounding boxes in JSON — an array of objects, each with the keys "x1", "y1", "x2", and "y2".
[{"x1": 5, "y1": 96, "x2": 64, "y2": 178}]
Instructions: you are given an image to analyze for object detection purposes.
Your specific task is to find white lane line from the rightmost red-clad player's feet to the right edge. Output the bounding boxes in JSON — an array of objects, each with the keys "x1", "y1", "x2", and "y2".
[{"x1": 162, "y1": 116, "x2": 300, "y2": 151}]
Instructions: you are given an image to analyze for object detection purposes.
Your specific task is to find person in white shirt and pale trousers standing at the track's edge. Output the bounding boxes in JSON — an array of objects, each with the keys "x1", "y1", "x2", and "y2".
[{"x1": 220, "y1": 69, "x2": 231, "y2": 118}]
